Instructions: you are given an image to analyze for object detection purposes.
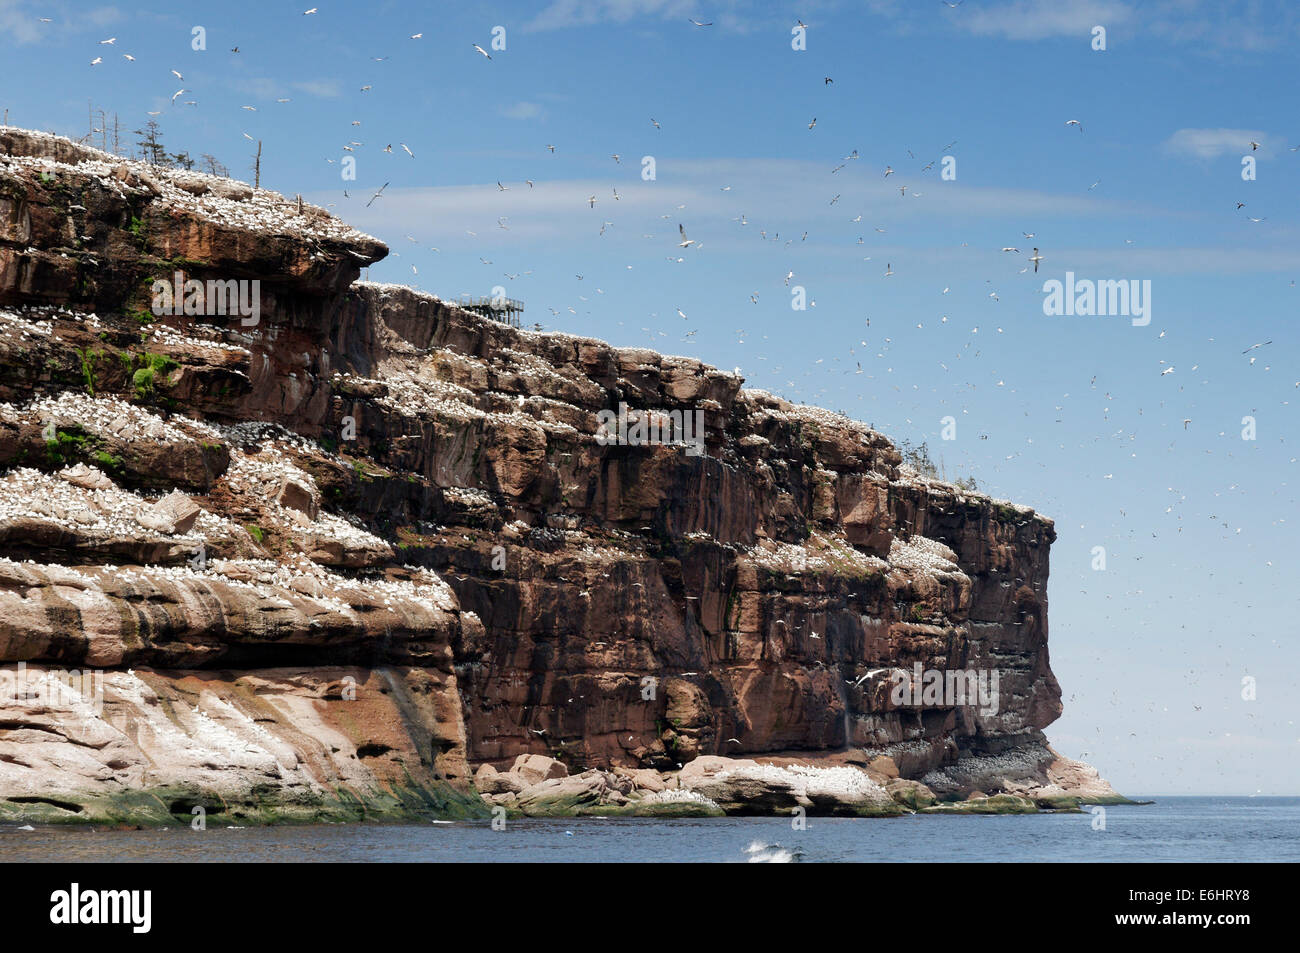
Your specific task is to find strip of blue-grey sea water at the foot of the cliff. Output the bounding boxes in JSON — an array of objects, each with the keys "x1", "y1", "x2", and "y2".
[{"x1": 0, "y1": 797, "x2": 1300, "y2": 863}]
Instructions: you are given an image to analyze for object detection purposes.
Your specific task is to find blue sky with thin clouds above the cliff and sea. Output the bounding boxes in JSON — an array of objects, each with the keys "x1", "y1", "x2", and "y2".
[{"x1": 0, "y1": 0, "x2": 1300, "y2": 794}]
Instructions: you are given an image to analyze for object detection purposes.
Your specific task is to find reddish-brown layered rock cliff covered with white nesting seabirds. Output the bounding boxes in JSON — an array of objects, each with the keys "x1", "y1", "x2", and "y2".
[{"x1": 0, "y1": 127, "x2": 1113, "y2": 822}]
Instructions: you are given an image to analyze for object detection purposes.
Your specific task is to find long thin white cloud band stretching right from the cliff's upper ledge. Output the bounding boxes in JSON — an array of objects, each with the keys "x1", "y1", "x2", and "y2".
[{"x1": 315, "y1": 159, "x2": 1164, "y2": 259}]
